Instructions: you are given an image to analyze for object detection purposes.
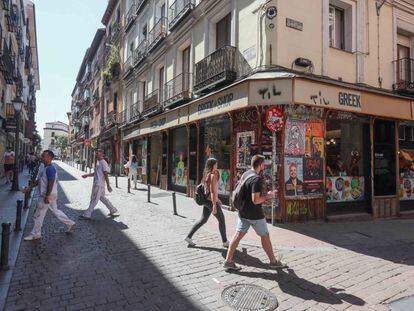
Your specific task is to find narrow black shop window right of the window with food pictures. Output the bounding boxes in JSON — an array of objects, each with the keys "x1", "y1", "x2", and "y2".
[{"x1": 374, "y1": 120, "x2": 396, "y2": 196}]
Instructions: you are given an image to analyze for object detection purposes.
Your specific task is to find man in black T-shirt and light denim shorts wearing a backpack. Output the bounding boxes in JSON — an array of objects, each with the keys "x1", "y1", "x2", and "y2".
[{"x1": 223, "y1": 155, "x2": 284, "y2": 271}]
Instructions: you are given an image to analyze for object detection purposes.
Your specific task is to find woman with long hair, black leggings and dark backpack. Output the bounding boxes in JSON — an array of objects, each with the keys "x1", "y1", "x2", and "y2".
[{"x1": 185, "y1": 158, "x2": 229, "y2": 248}]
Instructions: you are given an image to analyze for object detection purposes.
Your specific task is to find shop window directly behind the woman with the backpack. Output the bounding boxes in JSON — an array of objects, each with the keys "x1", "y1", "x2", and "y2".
[{"x1": 201, "y1": 116, "x2": 231, "y2": 196}]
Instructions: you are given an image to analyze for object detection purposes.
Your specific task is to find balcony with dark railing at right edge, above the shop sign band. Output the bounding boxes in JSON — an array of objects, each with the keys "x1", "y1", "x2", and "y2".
[{"x1": 392, "y1": 58, "x2": 414, "y2": 95}]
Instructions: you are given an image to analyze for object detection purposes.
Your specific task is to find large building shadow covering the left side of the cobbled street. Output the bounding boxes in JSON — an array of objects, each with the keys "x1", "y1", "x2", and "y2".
[{"x1": 5, "y1": 165, "x2": 199, "y2": 311}]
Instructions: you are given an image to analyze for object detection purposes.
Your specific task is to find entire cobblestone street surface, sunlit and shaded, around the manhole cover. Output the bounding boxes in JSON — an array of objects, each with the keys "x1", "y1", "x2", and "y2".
[{"x1": 6, "y1": 163, "x2": 414, "y2": 311}]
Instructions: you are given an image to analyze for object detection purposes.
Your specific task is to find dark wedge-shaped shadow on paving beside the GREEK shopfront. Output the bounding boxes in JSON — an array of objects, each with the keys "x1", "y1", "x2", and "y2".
[{"x1": 278, "y1": 219, "x2": 414, "y2": 265}]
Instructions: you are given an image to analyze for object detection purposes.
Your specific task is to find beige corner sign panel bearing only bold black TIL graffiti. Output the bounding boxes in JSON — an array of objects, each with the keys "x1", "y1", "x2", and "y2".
[{"x1": 249, "y1": 79, "x2": 292, "y2": 105}]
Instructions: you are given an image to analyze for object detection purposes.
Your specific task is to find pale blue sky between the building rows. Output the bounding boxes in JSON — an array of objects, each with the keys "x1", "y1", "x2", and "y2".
[{"x1": 32, "y1": 0, "x2": 108, "y2": 137}]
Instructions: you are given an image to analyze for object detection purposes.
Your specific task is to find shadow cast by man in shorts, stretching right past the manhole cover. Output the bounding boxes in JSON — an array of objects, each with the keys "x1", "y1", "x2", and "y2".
[{"x1": 232, "y1": 269, "x2": 365, "y2": 306}]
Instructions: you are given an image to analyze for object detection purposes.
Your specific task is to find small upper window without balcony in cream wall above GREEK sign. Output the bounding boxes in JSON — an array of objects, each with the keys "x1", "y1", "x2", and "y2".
[{"x1": 329, "y1": 5, "x2": 345, "y2": 50}]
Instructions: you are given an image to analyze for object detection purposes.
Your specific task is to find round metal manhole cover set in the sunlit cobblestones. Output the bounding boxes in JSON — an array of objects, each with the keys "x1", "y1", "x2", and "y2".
[{"x1": 221, "y1": 284, "x2": 278, "y2": 311}]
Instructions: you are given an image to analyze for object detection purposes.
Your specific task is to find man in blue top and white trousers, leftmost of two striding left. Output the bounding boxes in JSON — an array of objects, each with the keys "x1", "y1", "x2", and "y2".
[{"x1": 23, "y1": 150, "x2": 75, "y2": 241}]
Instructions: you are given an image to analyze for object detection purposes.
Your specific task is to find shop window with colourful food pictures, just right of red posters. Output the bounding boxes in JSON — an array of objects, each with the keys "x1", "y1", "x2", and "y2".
[{"x1": 326, "y1": 114, "x2": 370, "y2": 203}]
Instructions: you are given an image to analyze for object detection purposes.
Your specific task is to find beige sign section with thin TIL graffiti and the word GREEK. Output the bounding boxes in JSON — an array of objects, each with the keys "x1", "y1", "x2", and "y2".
[{"x1": 295, "y1": 79, "x2": 363, "y2": 111}]
